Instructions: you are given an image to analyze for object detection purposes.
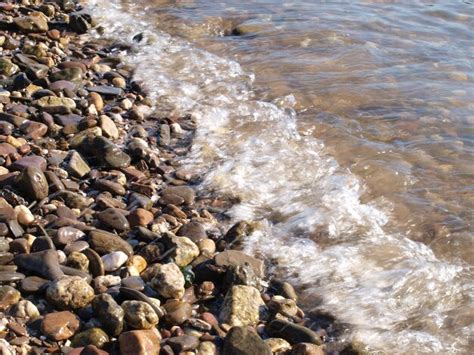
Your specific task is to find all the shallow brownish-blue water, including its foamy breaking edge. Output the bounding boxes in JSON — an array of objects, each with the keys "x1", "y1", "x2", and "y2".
[{"x1": 87, "y1": 0, "x2": 474, "y2": 354}]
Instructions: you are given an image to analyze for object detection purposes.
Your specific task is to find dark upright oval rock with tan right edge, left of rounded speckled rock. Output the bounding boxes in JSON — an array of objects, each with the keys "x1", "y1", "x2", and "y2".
[{"x1": 92, "y1": 293, "x2": 125, "y2": 336}]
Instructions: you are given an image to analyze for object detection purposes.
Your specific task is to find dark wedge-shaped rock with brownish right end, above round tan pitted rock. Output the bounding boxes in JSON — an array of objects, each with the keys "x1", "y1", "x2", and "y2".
[{"x1": 14, "y1": 250, "x2": 64, "y2": 280}]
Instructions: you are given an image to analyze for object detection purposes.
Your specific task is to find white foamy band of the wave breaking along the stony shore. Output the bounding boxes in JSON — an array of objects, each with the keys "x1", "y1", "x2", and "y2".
[{"x1": 91, "y1": 1, "x2": 473, "y2": 354}]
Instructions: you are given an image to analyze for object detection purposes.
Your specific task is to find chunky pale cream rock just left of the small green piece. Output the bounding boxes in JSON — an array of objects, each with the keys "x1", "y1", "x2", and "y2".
[{"x1": 151, "y1": 263, "x2": 185, "y2": 298}]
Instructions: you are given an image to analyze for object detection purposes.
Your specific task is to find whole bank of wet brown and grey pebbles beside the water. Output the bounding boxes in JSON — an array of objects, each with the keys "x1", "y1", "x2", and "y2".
[{"x1": 0, "y1": 0, "x2": 352, "y2": 355}]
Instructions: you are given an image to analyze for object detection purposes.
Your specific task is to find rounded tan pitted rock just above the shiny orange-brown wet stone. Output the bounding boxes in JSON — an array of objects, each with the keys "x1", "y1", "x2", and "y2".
[{"x1": 46, "y1": 276, "x2": 94, "y2": 309}]
